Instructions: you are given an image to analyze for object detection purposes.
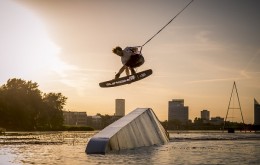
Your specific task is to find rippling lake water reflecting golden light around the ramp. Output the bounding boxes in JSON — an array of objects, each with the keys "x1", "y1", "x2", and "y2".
[{"x1": 0, "y1": 131, "x2": 260, "y2": 165}]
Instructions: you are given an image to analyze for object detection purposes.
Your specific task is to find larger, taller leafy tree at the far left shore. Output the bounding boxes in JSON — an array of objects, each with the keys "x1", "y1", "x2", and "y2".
[{"x1": 0, "y1": 78, "x2": 41, "y2": 130}]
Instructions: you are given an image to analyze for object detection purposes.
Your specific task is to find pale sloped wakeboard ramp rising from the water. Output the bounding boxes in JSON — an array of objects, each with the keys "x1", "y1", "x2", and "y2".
[{"x1": 86, "y1": 108, "x2": 169, "y2": 154}]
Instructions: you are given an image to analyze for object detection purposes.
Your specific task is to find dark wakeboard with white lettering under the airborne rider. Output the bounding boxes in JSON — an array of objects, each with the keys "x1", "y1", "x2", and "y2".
[{"x1": 99, "y1": 69, "x2": 153, "y2": 88}]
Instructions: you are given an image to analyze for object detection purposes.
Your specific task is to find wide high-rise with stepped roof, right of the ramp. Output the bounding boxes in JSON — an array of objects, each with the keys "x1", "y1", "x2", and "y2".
[{"x1": 168, "y1": 99, "x2": 189, "y2": 123}]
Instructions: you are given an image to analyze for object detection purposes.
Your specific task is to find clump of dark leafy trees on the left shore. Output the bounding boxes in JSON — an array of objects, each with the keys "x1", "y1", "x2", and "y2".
[{"x1": 0, "y1": 78, "x2": 67, "y2": 131}]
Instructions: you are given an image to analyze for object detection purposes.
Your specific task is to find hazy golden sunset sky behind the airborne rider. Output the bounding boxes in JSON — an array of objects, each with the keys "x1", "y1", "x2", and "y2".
[{"x1": 0, "y1": 0, "x2": 260, "y2": 123}]
